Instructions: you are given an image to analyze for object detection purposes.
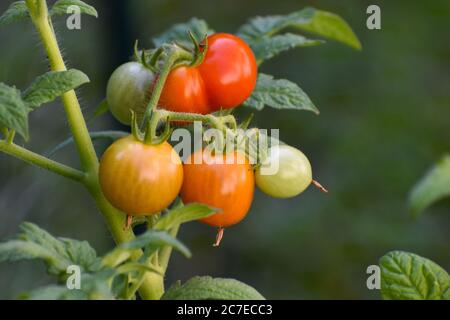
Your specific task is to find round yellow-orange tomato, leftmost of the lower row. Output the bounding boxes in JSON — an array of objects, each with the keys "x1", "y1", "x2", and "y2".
[{"x1": 99, "y1": 136, "x2": 183, "y2": 216}]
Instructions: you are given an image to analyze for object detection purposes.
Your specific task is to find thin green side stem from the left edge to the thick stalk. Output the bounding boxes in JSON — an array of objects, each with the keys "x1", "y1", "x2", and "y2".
[{"x1": 0, "y1": 141, "x2": 85, "y2": 181}]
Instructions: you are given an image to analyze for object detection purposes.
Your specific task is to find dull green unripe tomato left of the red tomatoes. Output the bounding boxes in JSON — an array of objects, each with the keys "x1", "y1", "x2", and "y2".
[{"x1": 106, "y1": 62, "x2": 155, "y2": 125}]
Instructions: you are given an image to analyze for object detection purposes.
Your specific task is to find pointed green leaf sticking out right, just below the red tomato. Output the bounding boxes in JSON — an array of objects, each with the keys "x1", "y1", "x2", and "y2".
[{"x1": 244, "y1": 73, "x2": 319, "y2": 114}]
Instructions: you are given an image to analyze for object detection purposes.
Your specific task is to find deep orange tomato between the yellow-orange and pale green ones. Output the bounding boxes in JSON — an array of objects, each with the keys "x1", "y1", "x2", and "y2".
[{"x1": 181, "y1": 150, "x2": 255, "y2": 227}]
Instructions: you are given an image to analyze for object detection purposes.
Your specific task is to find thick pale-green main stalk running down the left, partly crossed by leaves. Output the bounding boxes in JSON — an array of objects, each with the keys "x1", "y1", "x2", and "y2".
[{"x1": 26, "y1": 0, "x2": 164, "y2": 299}]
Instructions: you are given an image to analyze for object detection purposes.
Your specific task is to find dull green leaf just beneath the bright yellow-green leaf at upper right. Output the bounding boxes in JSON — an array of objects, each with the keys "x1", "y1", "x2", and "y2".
[{"x1": 251, "y1": 33, "x2": 325, "y2": 64}]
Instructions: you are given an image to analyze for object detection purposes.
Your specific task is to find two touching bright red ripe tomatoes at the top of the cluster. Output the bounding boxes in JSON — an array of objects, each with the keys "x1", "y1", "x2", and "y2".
[{"x1": 159, "y1": 33, "x2": 257, "y2": 114}]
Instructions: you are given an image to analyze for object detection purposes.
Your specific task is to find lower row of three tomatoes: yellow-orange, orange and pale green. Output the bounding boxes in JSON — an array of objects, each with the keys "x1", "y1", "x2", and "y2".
[{"x1": 99, "y1": 136, "x2": 312, "y2": 228}]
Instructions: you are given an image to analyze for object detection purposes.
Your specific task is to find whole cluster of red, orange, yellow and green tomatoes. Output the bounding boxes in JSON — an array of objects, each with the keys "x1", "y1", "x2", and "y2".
[{"x1": 99, "y1": 33, "x2": 320, "y2": 241}]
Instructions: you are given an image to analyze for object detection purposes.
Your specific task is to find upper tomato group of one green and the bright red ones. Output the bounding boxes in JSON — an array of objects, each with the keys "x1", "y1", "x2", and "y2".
[{"x1": 106, "y1": 33, "x2": 257, "y2": 124}]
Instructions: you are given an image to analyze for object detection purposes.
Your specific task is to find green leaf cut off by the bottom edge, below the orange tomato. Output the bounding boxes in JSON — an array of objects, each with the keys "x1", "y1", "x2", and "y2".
[{"x1": 162, "y1": 276, "x2": 264, "y2": 300}]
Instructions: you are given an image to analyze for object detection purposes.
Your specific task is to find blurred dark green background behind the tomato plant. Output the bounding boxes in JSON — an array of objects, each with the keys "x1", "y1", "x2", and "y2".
[{"x1": 0, "y1": 0, "x2": 450, "y2": 299}]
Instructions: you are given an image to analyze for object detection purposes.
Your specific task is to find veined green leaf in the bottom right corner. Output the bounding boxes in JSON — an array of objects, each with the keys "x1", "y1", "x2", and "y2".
[{"x1": 380, "y1": 251, "x2": 450, "y2": 300}]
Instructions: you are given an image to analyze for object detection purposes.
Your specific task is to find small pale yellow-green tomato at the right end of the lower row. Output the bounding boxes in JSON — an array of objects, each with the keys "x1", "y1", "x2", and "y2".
[{"x1": 255, "y1": 145, "x2": 312, "y2": 198}]
